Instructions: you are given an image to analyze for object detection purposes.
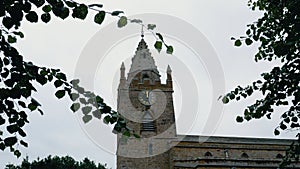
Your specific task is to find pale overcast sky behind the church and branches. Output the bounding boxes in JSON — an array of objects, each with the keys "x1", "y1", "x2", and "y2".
[{"x1": 0, "y1": 0, "x2": 294, "y2": 168}]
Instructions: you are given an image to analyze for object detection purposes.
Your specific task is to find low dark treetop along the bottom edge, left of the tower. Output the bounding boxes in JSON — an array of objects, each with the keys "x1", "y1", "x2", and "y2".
[{"x1": 5, "y1": 156, "x2": 106, "y2": 169}]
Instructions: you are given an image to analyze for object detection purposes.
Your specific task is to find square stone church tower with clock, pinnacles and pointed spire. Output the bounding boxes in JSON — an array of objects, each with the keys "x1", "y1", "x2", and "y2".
[{"x1": 117, "y1": 36, "x2": 176, "y2": 169}]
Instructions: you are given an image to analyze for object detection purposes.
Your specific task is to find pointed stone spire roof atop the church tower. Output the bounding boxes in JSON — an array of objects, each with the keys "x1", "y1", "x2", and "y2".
[{"x1": 129, "y1": 38, "x2": 158, "y2": 73}]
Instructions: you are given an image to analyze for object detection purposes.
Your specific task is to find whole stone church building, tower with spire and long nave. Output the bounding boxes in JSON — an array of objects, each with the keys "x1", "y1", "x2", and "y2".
[{"x1": 117, "y1": 37, "x2": 300, "y2": 169}]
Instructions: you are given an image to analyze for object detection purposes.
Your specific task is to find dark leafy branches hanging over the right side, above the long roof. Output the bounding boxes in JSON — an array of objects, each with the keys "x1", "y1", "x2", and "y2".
[{"x1": 222, "y1": 0, "x2": 300, "y2": 168}]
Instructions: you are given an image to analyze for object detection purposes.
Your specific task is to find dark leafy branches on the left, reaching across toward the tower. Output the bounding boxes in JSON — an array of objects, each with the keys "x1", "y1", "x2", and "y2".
[{"x1": 0, "y1": 0, "x2": 173, "y2": 157}]
